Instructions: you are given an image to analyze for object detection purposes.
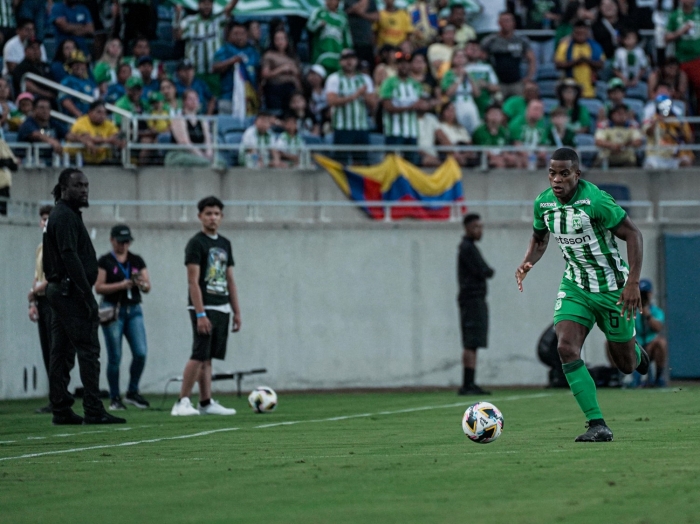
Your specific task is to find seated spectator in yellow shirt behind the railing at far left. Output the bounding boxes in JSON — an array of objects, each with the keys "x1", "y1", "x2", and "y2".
[{"x1": 71, "y1": 100, "x2": 124, "y2": 164}]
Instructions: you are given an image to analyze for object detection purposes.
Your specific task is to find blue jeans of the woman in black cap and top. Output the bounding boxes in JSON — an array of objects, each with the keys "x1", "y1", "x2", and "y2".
[{"x1": 102, "y1": 302, "x2": 148, "y2": 399}]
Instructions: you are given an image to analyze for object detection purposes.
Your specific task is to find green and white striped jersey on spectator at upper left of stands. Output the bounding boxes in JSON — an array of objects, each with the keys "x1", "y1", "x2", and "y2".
[{"x1": 180, "y1": 13, "x2": 226, "y2": 74}]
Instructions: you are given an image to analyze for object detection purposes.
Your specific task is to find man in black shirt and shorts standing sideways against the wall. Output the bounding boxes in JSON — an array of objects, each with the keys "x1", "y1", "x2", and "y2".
[{"x1": 457, "y1": 214, "x2": 494, "y2": 395}]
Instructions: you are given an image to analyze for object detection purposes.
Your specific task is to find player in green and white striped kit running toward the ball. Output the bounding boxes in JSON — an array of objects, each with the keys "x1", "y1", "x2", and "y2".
[{"x1": 515, "y1": 148, "x2": 649, "y2": 442}]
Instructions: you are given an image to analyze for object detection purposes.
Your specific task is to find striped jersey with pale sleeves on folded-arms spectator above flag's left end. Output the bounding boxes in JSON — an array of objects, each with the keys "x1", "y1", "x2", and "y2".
[{"x1": 326, "y1": 71, "x2": 374, "y2": 131}]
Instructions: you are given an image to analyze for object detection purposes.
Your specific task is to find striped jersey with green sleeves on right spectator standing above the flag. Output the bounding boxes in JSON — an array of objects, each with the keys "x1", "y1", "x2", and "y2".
[{"x1": 379, "y1": 76, "x2": 423, "y2": 138}]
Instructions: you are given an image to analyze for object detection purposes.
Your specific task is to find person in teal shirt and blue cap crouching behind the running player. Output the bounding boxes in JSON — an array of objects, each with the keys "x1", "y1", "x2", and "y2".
[{"x1": 635, "y1": 278, "x2": 668, "y2": 388}]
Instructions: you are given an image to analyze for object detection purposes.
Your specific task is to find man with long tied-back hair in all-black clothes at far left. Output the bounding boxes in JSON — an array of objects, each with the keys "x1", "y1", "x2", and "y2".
[{"x1": 44, "y1": 168, "x2": 126, "y2": 425}]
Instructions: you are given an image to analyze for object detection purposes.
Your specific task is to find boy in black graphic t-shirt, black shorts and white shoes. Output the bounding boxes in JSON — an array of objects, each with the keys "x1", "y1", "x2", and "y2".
[{"x1": 170, "y1": 196, "x2": 241, "y2": 416}]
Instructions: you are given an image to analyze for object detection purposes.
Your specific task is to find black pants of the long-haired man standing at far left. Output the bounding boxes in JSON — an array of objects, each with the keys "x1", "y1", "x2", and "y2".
[{"x1": 46, "y1": 283, "x2": 105, "y2": 416}]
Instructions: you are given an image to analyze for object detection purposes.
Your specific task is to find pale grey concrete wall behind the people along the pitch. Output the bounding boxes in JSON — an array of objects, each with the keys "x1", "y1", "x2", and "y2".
[{"x1": 0, "y1": 219, "x2": 659, "y2": 398}]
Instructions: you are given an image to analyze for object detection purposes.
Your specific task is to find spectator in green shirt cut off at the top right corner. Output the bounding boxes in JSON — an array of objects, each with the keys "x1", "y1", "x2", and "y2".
[{"x1": 666, "y1": 0, "x2": 700, "y2": 108}]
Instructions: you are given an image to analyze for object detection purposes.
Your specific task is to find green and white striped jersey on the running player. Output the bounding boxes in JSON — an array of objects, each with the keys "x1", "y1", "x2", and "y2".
[{"x1": 533, "y1": 180, "x2": 629, "y2": 293}]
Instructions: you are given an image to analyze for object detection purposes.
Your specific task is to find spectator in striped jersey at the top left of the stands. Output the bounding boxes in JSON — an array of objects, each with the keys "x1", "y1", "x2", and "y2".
[{"x1": 173, "y1": 0, "x2": 238, "y2": 96}]
